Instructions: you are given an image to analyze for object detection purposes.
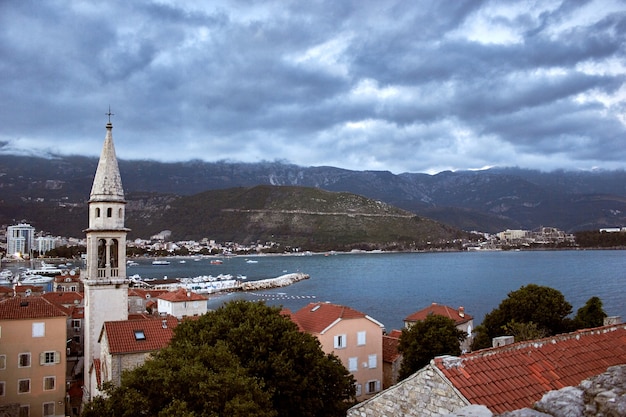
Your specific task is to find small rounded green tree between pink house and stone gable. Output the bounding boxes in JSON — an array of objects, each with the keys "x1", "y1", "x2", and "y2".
[{"x1": 398, "y1": 314, "x2": 466, "y2": 380}]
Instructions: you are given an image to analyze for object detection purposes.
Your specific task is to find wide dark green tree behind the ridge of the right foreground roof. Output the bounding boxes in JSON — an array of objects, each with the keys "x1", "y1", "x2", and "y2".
[{"x1": 472, "y1": 284, "x2": 572, "y2": 350}]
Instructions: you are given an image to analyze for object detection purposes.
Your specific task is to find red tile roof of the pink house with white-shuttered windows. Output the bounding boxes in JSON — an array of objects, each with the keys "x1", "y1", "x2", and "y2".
[{"x1": 291, "y1": 303, "x2": 367, "y2": 333}]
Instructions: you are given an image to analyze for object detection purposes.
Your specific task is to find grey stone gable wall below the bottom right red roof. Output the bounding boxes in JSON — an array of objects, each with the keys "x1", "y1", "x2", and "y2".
[{"x1": 347, "y1": 365, "x2": 469, "y2": 417}]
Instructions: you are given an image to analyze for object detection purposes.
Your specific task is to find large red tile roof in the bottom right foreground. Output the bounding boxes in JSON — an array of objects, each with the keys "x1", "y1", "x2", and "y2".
[{"x1": 434, "y1": 324, "x2": 626, "y2": 413}]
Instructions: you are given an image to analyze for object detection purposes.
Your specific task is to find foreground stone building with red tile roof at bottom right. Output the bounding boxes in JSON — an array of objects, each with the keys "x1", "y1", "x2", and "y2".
[{"x1": 347, "y1": 324, "x2": 626, "y2": 417}]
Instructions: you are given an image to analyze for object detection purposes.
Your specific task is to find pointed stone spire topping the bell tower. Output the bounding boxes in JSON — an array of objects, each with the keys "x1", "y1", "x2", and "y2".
[{"x1": 89, "y1": 116, "x2": 124, "y2": 202}]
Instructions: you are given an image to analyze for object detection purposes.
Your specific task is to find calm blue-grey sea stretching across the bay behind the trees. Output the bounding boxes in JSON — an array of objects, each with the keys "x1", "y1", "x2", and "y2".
[{"x1": 127, "y1": 250, "x2": 626, "y2": 330}]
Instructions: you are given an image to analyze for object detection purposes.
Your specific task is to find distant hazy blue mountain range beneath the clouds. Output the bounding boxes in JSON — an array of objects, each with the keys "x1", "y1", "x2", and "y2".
[{"x1": 0, "y1": 155, "x2": 626, "y2": 239}]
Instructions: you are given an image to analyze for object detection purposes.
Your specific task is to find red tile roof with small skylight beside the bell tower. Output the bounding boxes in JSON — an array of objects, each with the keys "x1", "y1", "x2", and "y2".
[{"x1": 103, "y1": 316, "x2": 178, "y2": 355}]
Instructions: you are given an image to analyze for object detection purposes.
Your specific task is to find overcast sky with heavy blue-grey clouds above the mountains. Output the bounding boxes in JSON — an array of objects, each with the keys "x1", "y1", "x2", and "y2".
[{"x1": 0, "y1": 0, "x2": 626, "y2": 173}]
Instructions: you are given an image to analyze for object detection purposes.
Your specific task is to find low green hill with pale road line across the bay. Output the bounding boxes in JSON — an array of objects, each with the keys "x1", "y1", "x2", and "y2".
[{"x1": 128, "y1": 185, "x2": 466, "y2": 250}]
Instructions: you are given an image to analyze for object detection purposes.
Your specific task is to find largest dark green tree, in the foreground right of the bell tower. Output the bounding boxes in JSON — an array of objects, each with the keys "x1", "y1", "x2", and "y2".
[{"x1": 84, "y1": 301, "x2": 355, "y2": 417}]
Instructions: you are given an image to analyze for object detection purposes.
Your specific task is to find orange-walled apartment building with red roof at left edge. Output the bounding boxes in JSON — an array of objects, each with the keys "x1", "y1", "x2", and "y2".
[{"x1": 0, "y1": 297, "x2": 67, "y2": 417}]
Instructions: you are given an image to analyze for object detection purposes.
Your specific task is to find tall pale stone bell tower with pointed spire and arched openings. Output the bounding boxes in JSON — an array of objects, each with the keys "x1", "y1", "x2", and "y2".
[{"x1": 81, "y1": 110, "x2": 129, "y2": 401}]
